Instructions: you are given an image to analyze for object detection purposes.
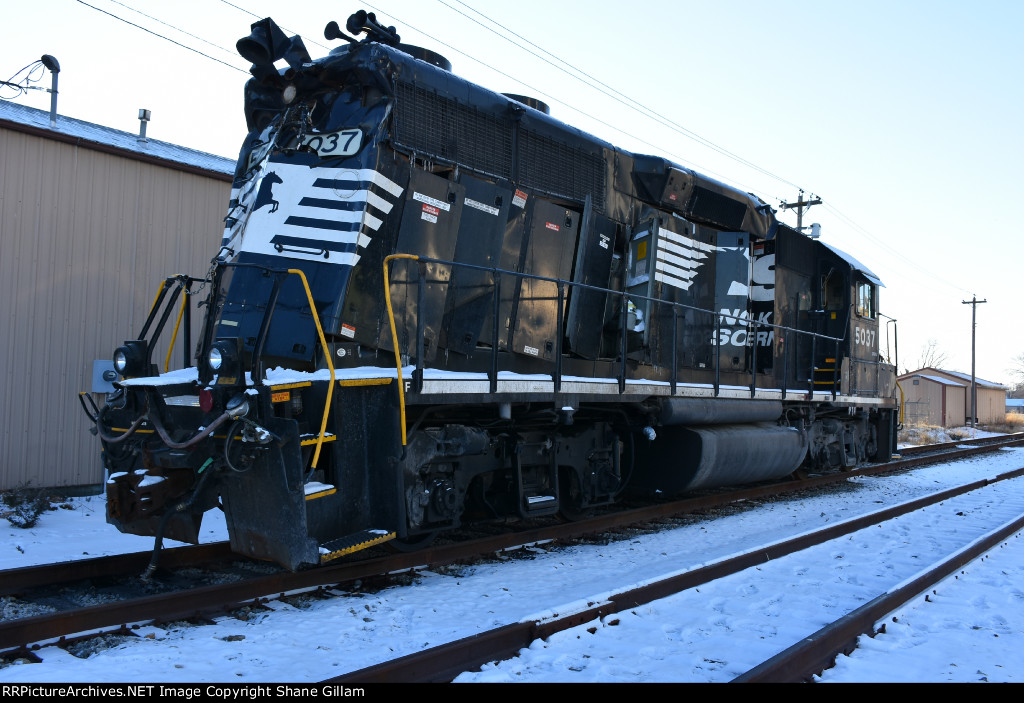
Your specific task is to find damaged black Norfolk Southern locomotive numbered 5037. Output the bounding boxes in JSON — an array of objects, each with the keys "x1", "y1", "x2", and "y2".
[{"x1": 87, "y1": 11, "x2": 898, "y2": 570}]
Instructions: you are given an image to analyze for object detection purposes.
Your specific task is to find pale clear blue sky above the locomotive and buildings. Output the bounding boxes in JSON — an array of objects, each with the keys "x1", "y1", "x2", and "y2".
[{"x1": 8, "y1": 0, "x2": 1024, "y2": 383}]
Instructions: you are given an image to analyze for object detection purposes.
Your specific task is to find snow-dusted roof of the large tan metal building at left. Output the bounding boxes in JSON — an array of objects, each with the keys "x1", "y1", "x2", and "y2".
[{"x1": 0, "y1": 99, "x2": 234, "y2": 176}]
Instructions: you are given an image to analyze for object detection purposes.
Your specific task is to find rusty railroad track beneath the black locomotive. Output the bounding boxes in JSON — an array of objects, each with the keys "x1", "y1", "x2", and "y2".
[{"x1": 0, "y1": 438, "x2": 1024, "y2": 671}]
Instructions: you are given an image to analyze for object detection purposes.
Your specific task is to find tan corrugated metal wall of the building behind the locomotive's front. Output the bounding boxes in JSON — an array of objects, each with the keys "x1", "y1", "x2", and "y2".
[{"x1": 0, "y1": 127, "x2": 230, "y2": 490}]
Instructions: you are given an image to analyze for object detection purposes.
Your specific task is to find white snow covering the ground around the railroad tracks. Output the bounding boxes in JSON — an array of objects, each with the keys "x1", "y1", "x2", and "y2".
[{"x1": 0, "y1": 440, "x2": 1024, "y2": 684}]
